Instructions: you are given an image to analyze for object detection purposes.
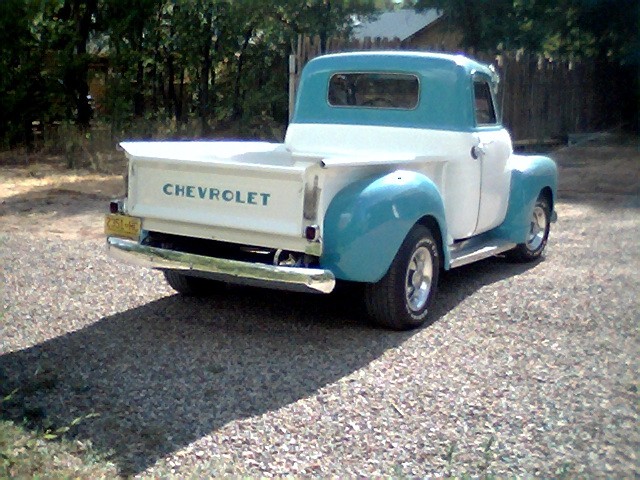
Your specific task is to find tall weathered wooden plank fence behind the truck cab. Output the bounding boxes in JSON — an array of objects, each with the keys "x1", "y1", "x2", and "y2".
[{"x1": 289, "y1": 37, "x2": 625, "y2": 145}]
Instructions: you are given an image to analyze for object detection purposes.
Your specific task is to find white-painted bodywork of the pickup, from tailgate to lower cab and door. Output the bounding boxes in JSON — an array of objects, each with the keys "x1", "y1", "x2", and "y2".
[{"x1": 122, "y1": 124, "x2": 511, "y2": 251}]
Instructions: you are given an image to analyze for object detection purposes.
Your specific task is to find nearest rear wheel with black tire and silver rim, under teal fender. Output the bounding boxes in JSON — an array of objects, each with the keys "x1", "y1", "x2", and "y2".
[{"x1": 365, "y1": 225, "x2": 440, "y2": 330}]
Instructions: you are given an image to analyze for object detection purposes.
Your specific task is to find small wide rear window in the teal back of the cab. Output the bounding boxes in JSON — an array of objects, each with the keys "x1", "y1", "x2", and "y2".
[{"x1": 328, "y1": 72, "x2": 420, "y2": 110}]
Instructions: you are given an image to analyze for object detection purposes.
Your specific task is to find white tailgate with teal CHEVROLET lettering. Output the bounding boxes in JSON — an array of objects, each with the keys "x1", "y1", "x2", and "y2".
[{"x1": 123, "y1": 142, "x2": 309, "y2": 237}]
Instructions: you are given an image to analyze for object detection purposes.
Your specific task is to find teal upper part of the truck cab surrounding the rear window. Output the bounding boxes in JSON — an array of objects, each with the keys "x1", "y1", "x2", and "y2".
[{"x1": 292, "y1": 52, "x2": 492, "y2": 132}]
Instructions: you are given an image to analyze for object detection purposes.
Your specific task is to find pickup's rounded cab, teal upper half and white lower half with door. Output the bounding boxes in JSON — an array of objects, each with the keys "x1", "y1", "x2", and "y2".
[{"x1": 285, "y1": 52, "x2": 513, "y2": 239}]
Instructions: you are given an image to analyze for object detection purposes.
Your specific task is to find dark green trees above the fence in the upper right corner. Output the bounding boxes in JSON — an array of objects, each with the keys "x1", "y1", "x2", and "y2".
[{"x1": 411, "y1": 0, "x2": 640, "y2": 65}]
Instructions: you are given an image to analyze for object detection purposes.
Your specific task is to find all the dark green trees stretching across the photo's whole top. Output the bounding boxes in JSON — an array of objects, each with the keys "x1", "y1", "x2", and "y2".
[{"x1": 5, "y1": 0, "x2": 640, "y2": 150}]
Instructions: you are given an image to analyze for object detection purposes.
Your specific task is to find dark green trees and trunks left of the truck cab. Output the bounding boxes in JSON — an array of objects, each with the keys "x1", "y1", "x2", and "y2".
[{"x1": 0, "y1": 0, "x2": 374, "y2": 148}]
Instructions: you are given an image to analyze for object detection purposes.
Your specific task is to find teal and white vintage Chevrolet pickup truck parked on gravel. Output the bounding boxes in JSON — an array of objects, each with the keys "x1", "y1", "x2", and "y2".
[{"x1": 105, "y1": 52, "x2": 557, "y2": 330}]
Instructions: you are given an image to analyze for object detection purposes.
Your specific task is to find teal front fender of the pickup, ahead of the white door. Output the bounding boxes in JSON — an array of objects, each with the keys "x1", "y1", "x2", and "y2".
[{"x1": 487, "y1": 155, "x2": 558, "y2": 243}]
